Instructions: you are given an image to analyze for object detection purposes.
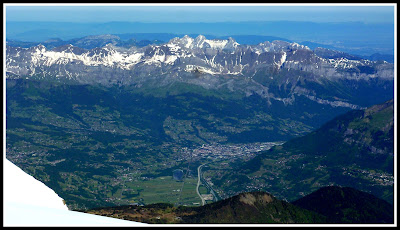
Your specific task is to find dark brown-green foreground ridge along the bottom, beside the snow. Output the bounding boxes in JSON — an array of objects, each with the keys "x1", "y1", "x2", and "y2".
[{"x1": 85, "y1": 186, "x2": 393, "y2": 224}]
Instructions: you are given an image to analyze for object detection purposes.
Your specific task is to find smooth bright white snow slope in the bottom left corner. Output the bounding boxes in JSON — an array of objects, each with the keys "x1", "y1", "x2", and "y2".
[{"x1": 3, "y1": 158, "x2": 146, "y2": 226}]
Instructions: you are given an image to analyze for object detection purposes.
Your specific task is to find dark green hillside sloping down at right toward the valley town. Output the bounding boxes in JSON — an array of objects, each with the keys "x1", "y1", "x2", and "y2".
[{"x1": 213, "y1": 100, "x2": 394, "y2": 203}]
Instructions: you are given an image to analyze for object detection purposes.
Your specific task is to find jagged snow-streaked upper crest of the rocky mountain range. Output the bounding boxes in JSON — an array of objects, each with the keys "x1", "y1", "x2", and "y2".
[{"x1": 7, "y1": 35, "x2": 390, "y2": 78}]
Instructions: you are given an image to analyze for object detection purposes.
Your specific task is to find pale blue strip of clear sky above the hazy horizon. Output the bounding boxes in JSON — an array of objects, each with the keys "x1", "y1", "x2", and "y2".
[{"x1": 6, "y1": 4, "x2": 395, "y2": 23}]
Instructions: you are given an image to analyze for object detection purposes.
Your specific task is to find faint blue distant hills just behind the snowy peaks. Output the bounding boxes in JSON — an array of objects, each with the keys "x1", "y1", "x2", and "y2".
[{"x1": 6, "y1": 33, "x2": 394, "y2": 63}]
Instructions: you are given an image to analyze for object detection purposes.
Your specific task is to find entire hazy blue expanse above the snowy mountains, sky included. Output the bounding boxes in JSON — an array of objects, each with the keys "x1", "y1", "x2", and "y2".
[{"x1": 4, "y1": 4, "x2": 396, "y2": 54}]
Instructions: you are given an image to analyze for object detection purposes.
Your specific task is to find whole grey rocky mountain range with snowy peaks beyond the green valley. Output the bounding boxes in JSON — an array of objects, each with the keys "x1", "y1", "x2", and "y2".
[{"x1": 6, "y1": 35, "x2": 393, "y2": 108}]
